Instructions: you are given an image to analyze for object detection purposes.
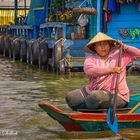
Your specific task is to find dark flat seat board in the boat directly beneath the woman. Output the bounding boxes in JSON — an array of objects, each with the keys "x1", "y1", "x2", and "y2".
[{"x1": 77, "y1": 108, "x2": 132, "y2": 113}]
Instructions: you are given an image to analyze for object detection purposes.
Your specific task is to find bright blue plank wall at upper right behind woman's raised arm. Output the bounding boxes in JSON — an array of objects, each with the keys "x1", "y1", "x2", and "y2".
[{"x1": 107, "y1": 3, "x2": 140, "y2": 48}]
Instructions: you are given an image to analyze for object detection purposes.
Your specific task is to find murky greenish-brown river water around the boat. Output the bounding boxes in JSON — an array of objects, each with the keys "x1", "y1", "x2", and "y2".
[{"x1": 0, "y1": 58, "x2": 140, "y2": 140}]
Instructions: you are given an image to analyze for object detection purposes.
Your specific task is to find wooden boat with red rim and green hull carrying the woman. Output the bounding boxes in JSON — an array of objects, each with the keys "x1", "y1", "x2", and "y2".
[{"x1": 39, "y1": 95, "x2": 140, "y2": 131}]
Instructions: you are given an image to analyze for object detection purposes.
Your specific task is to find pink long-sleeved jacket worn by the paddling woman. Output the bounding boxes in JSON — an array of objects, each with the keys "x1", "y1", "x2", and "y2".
[{"x1": 84, "y1": 45, "x2": 140, "y2": 102}]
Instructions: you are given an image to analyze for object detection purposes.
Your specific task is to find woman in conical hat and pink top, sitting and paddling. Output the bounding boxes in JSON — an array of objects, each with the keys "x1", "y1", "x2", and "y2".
[{"x1": 66, "y1": 32, "x2": 140, "y2": 110}]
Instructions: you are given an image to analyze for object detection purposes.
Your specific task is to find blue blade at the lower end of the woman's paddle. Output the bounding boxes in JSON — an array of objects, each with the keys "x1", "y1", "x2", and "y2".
[{"x1": 106, "y1": 108, "x2": 118, "y2": 134}]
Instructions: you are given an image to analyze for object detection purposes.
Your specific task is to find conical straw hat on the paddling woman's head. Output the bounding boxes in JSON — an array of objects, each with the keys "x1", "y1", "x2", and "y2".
[{"x1": 84, "y1": 32, "x2": 116, "y2": 53}]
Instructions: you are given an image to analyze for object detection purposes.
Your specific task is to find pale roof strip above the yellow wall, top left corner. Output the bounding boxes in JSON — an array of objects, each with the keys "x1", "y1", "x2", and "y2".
[{"x1": 0, "y1": 0, "x2": 30, "y2": 8}]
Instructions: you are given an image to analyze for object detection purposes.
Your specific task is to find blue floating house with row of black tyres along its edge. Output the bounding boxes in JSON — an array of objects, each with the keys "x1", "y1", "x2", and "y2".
[{"x1": 0, "y1": 0, "x2": 140, "y2": 72}]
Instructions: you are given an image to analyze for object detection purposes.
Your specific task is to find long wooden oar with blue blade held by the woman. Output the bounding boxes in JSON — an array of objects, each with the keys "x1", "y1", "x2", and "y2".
[{"x1": 106, "y1": 46, "x2": 122, "y2": 134}]
